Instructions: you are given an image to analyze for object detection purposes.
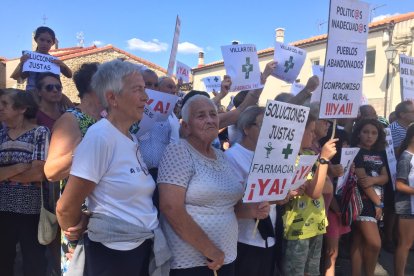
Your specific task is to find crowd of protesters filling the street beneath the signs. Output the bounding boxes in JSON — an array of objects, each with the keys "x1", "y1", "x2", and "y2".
[{"x1": 0, "y1": 27, "x2": 414, "y2": 276}]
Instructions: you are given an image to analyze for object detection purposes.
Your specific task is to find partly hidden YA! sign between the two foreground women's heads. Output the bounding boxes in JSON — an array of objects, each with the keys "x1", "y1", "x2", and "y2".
[{"x1": 145, "y1": 89, "x2": 178, "y2": 122}]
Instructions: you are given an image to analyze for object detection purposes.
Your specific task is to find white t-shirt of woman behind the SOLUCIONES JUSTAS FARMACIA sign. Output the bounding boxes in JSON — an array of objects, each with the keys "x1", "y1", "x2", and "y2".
[{"x1": 224, "y1": 143, "x2": 276, "y2": 248}]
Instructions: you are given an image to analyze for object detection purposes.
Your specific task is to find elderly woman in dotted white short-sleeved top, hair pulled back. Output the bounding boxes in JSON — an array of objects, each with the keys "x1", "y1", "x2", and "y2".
[{"x1": 157, "y1": 95, "x2": 269, "y2": 276}]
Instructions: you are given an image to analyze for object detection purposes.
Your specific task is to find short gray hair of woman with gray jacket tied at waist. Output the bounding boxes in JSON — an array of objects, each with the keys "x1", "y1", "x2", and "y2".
[{"x1": 91, "y1": 59, "x2": 141, "y2": 108}]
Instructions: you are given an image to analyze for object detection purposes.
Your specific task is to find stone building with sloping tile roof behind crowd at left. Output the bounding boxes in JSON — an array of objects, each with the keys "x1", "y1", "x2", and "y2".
[{"x1": 0, "y1": 45, "x2": 167, "y2": 102}]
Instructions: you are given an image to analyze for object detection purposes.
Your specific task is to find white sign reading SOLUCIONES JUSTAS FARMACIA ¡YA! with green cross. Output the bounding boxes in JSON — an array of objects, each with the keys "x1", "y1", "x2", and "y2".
[{"x1": 243, "y1": 100, "x2": 309, "y2": 202}]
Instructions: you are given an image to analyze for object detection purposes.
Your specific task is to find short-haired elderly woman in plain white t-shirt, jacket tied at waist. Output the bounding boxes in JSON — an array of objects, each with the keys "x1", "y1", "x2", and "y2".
[{"x1": 57, "y1": 60, "x2": 166, "y2": 275}]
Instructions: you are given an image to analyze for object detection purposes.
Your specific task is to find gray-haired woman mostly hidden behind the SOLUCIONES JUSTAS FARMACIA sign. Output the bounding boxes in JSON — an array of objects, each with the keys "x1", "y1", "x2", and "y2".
[{"x1": 225, "y1": 106, "x2": 276, "y2": 276}]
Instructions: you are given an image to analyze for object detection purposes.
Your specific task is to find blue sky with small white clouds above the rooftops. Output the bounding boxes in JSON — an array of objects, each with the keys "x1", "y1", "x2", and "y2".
[{"x1": 0, "y1": 0, "x2": 414, "y2": 68}]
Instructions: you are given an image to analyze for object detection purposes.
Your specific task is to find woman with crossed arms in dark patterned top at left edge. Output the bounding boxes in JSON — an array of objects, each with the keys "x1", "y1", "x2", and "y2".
[{"x1": 0, "y1": 88, "x2": 49, "y2": 276}]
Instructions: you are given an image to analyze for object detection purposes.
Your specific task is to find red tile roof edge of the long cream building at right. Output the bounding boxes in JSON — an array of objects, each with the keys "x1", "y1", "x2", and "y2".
[{"x1": 193, "y1": 12, "x2": 414, "y2": 72}]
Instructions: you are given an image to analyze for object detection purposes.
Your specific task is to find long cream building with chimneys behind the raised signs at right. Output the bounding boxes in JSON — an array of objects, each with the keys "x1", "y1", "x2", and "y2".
[{"x1": 192, "y1": 12, "x2": 414, "y2": 115}]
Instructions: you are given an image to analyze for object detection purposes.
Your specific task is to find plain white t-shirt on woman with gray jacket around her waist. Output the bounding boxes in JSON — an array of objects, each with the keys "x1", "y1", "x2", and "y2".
[{"x1": 70, "y1": 119, "x2": 158, "y2": 250}]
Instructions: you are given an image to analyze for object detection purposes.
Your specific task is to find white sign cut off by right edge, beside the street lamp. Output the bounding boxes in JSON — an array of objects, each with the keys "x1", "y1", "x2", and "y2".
[{"x1": 400, "y1": 54, "x2": 414, "y2": 101}]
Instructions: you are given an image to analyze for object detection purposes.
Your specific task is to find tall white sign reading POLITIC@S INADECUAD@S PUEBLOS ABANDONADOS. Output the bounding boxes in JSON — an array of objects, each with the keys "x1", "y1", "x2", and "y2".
[{"x1": 319, "y1": 0, "x2": 369, "y2": 119}]
